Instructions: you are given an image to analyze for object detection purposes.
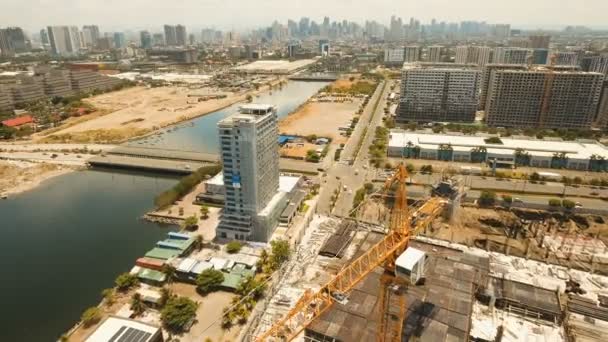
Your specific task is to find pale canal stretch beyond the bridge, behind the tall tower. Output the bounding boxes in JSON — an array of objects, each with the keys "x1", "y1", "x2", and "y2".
[{"x1": 129, "y1": 82, "x2": 329, "y2": 154}]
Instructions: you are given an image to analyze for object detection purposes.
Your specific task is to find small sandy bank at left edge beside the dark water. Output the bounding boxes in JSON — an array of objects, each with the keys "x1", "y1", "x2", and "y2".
[{"x1": 0, "y1": 160, "x2": 74, "y2": 195}]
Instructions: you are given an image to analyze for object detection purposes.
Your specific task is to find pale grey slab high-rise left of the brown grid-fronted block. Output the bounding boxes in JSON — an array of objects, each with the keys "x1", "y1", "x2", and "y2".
[{"x1": 397, "y1": 63, "x2": 480, "y2": 122}]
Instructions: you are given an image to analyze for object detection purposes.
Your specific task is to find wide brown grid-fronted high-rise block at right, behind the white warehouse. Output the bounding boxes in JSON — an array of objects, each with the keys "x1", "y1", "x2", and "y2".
[{"x1": 486, "y1": 68, "x2": 603, "y2": 129}]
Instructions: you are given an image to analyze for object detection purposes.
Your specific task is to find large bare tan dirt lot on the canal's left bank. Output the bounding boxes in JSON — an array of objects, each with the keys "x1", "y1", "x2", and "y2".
[{"x1": 37, "y1": 87, "x2": 245, "y2": 142}]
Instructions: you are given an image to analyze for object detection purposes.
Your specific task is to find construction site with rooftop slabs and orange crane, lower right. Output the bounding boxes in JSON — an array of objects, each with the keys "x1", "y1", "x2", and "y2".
[{"x1": 241, "y1": 166, "x2": 608, "y2": 342}]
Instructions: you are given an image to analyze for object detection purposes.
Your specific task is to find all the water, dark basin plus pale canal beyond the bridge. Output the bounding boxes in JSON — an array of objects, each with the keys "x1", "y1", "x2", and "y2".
[{"x1": 0, "y1": 82, "x2": 326, "y2": 342}]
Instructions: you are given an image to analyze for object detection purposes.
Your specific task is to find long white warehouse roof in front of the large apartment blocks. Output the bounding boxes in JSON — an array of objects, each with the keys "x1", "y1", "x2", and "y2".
[{"x1": 389, "y1": 130, "x2": 608, "y2": 160}]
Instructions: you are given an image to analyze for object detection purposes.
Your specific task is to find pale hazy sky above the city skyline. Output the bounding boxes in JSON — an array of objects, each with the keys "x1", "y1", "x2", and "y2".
[{"x1": 0, "y1": 0, "x2": 608, "y2": 31}]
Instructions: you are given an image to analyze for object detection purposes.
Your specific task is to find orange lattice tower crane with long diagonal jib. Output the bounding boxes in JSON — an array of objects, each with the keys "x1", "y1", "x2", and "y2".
[{"x1": 256, "y1": 164, "x2": 445, "y2": 341}]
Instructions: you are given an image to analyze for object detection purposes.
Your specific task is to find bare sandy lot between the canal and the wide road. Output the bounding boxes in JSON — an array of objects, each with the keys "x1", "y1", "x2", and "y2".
[{"x1": 279, "y1": 100, "x2": 360, "y2": 143}]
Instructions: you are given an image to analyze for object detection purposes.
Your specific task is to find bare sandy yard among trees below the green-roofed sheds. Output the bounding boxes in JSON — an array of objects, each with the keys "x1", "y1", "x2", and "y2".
[{"x1": 171, "y1": 283, "x2": 239, "y2": 342}]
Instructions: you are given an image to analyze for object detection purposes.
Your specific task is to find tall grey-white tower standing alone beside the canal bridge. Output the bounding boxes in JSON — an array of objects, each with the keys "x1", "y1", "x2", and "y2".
[{"x1": 217, "y1": 104, "x2": 282, "y2": 241}]
